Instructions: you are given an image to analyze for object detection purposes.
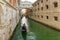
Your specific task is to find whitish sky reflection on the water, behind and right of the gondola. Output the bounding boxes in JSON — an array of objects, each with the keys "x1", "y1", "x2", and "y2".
[{"x1": 21, "y1": 17, "x2": 36, "y2": 40}]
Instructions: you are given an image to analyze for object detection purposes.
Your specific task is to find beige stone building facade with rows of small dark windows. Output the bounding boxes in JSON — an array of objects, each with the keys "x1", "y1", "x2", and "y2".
[{"x1": 30, "y1": 0, "x2": 60, "y2": 30}]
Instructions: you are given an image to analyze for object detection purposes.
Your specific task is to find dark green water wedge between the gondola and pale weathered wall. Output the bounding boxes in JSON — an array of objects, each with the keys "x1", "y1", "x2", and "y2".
[{"x1": 10, "y1": 22, "x2": 23, "y2": 40}]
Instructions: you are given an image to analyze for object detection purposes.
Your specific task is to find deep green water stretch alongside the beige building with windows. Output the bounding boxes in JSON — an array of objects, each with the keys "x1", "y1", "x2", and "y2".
[{"x1": 29, "y1": 19, "x2": 60, "y2": 40}]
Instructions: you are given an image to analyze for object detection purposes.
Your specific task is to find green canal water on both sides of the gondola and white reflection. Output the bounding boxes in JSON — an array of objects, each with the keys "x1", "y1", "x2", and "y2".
[{"x1": 11, "y1": 19, "x2": 60, "y2": 40}]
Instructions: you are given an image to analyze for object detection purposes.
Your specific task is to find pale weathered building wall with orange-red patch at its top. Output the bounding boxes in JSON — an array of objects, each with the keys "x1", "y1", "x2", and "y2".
[{"x1": 0, "y1": 0, "x2": 19, "y2": 40}]
